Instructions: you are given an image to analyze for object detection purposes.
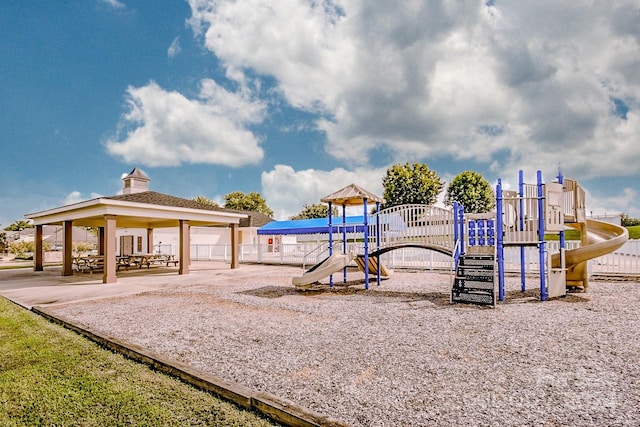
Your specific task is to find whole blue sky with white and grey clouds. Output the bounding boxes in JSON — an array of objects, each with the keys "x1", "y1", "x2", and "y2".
[{"x1": 0, "y1": 0, "x2": 640, "y2": 228}]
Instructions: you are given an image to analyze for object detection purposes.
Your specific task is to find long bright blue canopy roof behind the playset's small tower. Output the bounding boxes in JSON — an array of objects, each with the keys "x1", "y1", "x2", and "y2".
[{"x1": 258, "y1": 215, "x2": 371, "y2": 236}]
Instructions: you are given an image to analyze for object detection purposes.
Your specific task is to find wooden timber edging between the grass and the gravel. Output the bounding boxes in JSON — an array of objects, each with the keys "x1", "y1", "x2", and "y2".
[{"x1": 31, "y1": 307, "x2": 347, "y2": 427}]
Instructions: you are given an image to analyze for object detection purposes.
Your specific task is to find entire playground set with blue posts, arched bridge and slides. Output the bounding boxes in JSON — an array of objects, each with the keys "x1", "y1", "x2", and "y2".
[{"x1": 293, "y1": 171, "x2": 628, "y2": 305}]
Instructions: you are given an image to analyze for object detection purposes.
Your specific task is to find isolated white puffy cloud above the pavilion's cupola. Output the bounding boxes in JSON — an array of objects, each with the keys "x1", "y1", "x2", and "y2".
[{"x1": 105, "y1": 79, "x2": 265, "y2": 167}]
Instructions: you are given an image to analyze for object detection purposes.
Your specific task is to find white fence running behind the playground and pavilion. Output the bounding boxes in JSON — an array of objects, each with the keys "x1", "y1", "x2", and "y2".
[{"x1": 158, "y1": 240, "x2": 640, "y2": 275}]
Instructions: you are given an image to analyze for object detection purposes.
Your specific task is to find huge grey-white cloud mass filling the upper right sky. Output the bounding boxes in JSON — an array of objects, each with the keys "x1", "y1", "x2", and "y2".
[{"x1": 190, "y1": 0, "x2": 640, "y2": 177}]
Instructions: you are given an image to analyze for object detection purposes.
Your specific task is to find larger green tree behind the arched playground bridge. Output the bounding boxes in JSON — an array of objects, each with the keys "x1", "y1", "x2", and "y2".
[{"x1": 382, "y1": 163, "x2": 444, "y2": 209}]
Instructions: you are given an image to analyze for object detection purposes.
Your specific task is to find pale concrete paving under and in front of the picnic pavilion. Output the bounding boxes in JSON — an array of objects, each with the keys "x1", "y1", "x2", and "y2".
[{"x1": 0, "y1": 261, "x2": 299, "y2": 309}]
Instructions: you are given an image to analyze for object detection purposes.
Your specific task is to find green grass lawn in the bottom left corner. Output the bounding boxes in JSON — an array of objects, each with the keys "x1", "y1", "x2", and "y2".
[{"x1": 0, "y1": 298, "x2": 273, "y2": 426}]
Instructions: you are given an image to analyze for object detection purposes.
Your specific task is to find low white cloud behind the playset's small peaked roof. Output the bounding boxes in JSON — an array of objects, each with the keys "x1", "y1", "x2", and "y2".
[{"x1": 261, "y1": 165, "x2": 387, "y2": 219}]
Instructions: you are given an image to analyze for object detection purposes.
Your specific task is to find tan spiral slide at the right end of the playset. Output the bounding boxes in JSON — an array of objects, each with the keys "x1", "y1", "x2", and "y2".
[{"x1": 551, "y1": 219, "x2": 629, "y2": 290}]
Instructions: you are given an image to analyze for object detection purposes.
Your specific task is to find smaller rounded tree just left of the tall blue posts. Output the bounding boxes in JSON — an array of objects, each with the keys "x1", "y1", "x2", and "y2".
[{"x1": 444, "y1": 171, "x2": 496, "y2": 213}]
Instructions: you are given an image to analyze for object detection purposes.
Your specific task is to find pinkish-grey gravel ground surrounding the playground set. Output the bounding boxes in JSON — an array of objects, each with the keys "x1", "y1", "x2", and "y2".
[{"x1": 48, "y1": 267, "x2": 640, "y2": 426}]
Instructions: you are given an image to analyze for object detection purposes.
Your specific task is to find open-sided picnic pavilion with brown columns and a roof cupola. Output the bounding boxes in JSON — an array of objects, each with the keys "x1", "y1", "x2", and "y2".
[{"x1": 25, "y1": 168, "x2": 248, "y2": 283}]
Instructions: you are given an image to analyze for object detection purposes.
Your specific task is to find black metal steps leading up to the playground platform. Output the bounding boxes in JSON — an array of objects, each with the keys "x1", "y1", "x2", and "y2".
[{"x1": 451, "y1": 254, "x2": 496, "y2": 306}]
